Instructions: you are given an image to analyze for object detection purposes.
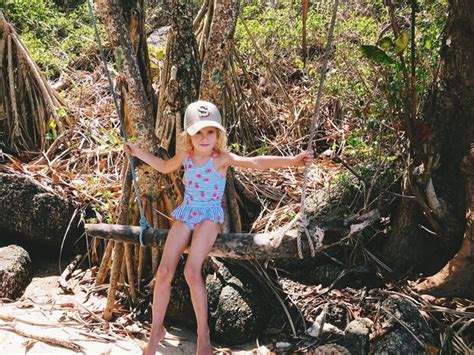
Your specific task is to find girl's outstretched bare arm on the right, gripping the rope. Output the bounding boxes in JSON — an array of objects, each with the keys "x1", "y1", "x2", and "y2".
[{"x1": 227, "y1": 150, "x2": 314, "y2": 170}]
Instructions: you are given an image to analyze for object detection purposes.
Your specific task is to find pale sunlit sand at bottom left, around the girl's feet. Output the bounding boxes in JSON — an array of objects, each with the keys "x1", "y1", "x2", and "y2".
[{"x1": 0, "y1": 266, "x2": 269, "y2": 354}]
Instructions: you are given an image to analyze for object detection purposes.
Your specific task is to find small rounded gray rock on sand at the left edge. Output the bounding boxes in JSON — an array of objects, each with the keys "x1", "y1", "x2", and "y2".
[{"x1": 0, "y1": 245, "x2": 31, "y2": 299}]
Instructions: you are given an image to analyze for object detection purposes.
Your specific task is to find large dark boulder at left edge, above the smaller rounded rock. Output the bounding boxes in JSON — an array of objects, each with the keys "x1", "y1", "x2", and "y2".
[{"x1": 0, "y1": 173, "x2": 84, "y2": 247}]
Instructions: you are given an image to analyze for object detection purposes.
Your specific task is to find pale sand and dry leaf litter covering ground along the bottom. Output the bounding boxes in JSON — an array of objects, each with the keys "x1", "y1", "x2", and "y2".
[{"x1": 0, "y1": 253, "x2": 474, "y2": 355}]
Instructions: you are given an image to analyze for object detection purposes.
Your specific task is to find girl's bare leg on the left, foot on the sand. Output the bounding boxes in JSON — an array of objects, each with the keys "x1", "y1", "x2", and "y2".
[{"x1": 143, "y1": 221, "x2": 191, "y2": 355}]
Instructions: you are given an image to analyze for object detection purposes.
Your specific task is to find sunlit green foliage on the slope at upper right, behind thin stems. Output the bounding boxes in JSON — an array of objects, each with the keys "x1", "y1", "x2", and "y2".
[{"x1": 234, "y1": 0, "x2": 447, "y2": 193}]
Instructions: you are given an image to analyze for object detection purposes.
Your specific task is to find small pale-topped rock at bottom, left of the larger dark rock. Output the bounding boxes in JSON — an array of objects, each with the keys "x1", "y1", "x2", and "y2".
[{"x1": 338, "y1": 318, "x2": 374, "y2": 354}]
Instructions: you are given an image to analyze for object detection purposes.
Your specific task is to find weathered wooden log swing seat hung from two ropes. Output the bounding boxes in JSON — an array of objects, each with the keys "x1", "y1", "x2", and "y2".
[{"x1": 85, "y1": 210, "x2": 380, "y2": 259}]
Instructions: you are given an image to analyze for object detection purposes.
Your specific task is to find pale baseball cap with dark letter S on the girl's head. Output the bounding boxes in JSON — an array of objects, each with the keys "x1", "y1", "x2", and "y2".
[{"x1": 184, "y1": 100, "x2": 226, "y2": 136}]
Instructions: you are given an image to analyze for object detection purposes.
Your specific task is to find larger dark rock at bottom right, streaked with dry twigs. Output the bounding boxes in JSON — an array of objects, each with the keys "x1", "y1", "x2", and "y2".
[{"x1": 370, "y1": 295, "x2": 436, "y2": 354}]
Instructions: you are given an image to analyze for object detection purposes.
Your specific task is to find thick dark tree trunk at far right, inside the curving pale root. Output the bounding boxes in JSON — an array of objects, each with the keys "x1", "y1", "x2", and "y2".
[{"x1": 385, "y1": 0, "x2": 474, "y2": 272}]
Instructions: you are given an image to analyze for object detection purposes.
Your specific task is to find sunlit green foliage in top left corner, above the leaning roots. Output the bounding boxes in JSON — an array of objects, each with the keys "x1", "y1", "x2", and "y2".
[{"x1": 5, "y1": 0, "x2": 97, "y2": 78}]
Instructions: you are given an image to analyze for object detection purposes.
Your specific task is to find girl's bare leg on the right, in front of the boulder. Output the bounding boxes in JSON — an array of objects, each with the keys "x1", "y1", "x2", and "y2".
[{"x1": 184, "y1": 221, "x2": 219, "y2": 355}]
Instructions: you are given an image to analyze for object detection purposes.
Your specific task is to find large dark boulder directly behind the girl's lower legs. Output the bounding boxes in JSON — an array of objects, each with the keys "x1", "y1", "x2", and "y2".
[{"x1": 167, "y1": 260, "x2": 270, "y2": 345}]
